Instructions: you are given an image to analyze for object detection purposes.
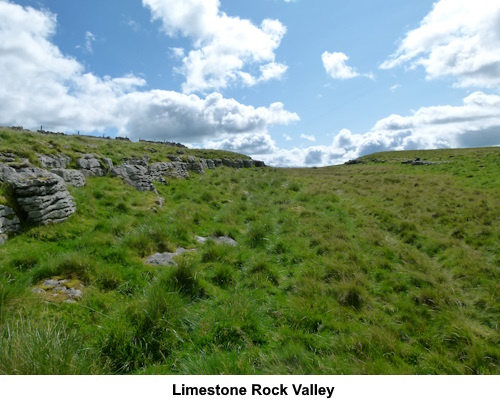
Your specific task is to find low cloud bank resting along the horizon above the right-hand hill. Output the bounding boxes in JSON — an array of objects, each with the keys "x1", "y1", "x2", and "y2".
[{"x1": 250, "y1": 92, "x2": 500, "y2": 166}]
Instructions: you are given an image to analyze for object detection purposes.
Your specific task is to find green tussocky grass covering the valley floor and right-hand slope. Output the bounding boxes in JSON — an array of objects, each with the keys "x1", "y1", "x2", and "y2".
[{"x1": 0, "y1": 132, "x2": 500, "y2": 374}]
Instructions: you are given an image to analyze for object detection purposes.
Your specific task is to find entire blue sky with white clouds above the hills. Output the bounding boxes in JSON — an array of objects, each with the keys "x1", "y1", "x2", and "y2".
[{"x1": 0, "y1": 0, "x2": 500, "y2": 167}]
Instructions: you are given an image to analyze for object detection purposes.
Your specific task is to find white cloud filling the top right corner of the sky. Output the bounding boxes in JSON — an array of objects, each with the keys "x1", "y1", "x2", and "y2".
[{"x1": 380, "y1": 0, "x2": 500, "y2": 88}]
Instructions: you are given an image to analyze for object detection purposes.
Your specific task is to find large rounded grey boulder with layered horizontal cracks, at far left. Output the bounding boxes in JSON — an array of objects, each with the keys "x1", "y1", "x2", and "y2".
[{"x1": 4, "y1": 168, "x2": 76, "y2": 224}]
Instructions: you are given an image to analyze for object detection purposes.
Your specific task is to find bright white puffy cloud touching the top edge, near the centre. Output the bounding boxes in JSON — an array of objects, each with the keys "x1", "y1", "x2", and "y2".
[{"x1": 142, "y1": 0, "x2": 287, "y2": 93}]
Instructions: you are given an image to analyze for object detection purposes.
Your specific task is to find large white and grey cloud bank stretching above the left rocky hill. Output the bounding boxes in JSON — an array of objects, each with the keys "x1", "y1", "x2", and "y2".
[{"x1": 0, "y1": 0, "x2": 299, "y2": 143}]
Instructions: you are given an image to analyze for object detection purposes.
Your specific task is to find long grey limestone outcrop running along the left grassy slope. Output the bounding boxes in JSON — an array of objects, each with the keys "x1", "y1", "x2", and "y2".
[{"x1": 0, "y1": 147, "x2": 265, "y2": 244}]
